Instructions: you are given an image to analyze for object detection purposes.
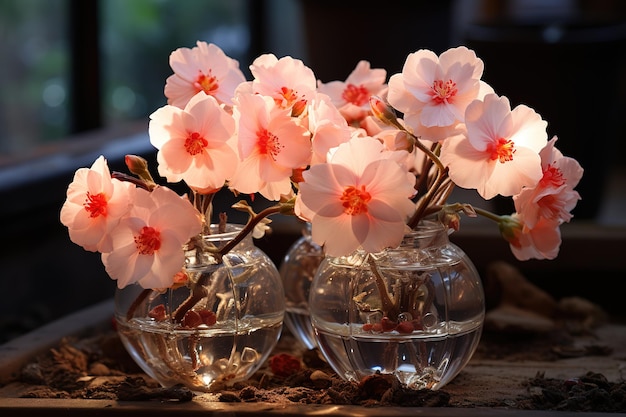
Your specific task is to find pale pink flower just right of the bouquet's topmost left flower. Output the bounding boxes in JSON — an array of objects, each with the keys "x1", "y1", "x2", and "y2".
[{"x1": 238, "y1": 54, "x2": 316, "y2": 109}]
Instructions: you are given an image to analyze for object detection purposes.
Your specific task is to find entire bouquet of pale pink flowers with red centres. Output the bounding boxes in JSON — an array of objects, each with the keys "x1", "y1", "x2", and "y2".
[{"x1": 60, "y1": 42, "x2": 583, "y2": 288}]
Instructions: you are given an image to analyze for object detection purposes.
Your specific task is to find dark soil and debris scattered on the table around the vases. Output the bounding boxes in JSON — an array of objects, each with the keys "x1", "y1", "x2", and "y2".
[{"x1": 0, "y1": 263, "x2": 626, "y2": 412}]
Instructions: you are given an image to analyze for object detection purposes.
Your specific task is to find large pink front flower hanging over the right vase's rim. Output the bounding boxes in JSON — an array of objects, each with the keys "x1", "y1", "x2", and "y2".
[{"x1": 295, "y1": 137, "x2": 415, "y2": 256}]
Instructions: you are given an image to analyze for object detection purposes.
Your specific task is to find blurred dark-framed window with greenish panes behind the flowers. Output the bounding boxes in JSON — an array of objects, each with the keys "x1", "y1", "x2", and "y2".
[{"x1": 0, "y1": 0, "x2": 252, "y2": 166}]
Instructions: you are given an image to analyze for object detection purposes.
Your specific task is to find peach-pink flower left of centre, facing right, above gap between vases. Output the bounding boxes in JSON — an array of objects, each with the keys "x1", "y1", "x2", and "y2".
[{"x1": 229, "y1": 94, "x2": 311, "y2": 201}]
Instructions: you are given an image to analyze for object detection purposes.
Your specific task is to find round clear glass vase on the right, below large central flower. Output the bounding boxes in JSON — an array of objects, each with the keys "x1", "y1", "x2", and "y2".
[{"x1": 309, "y1": 222, "x2": 485, "y2": 390}]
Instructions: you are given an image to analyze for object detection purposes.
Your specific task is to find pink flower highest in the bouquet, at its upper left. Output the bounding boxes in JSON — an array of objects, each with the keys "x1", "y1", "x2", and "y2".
[{"x1": 164, "y1": 41, "x2": 246, "y2": 109}]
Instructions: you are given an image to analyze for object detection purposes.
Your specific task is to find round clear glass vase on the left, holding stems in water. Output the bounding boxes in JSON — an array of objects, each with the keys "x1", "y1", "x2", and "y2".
[{"x1": 115, "y1": 224, "x2": 285, "y2": 392}]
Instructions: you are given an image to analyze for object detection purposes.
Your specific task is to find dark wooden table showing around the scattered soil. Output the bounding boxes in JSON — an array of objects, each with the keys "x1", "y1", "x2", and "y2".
[{"x1": 0, "y1": 301, "x2": 626, "y2": 417}]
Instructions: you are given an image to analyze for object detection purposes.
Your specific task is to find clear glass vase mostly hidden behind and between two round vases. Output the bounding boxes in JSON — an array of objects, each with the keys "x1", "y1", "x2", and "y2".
[{"x1": 279, "y1": 223, "x2": 324, "y2": 349}]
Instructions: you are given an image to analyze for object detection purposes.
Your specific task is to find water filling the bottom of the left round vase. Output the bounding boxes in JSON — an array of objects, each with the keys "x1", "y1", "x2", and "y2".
[{"x1": 117, "y1": 315, "x2": 282, "y2": 392}]
